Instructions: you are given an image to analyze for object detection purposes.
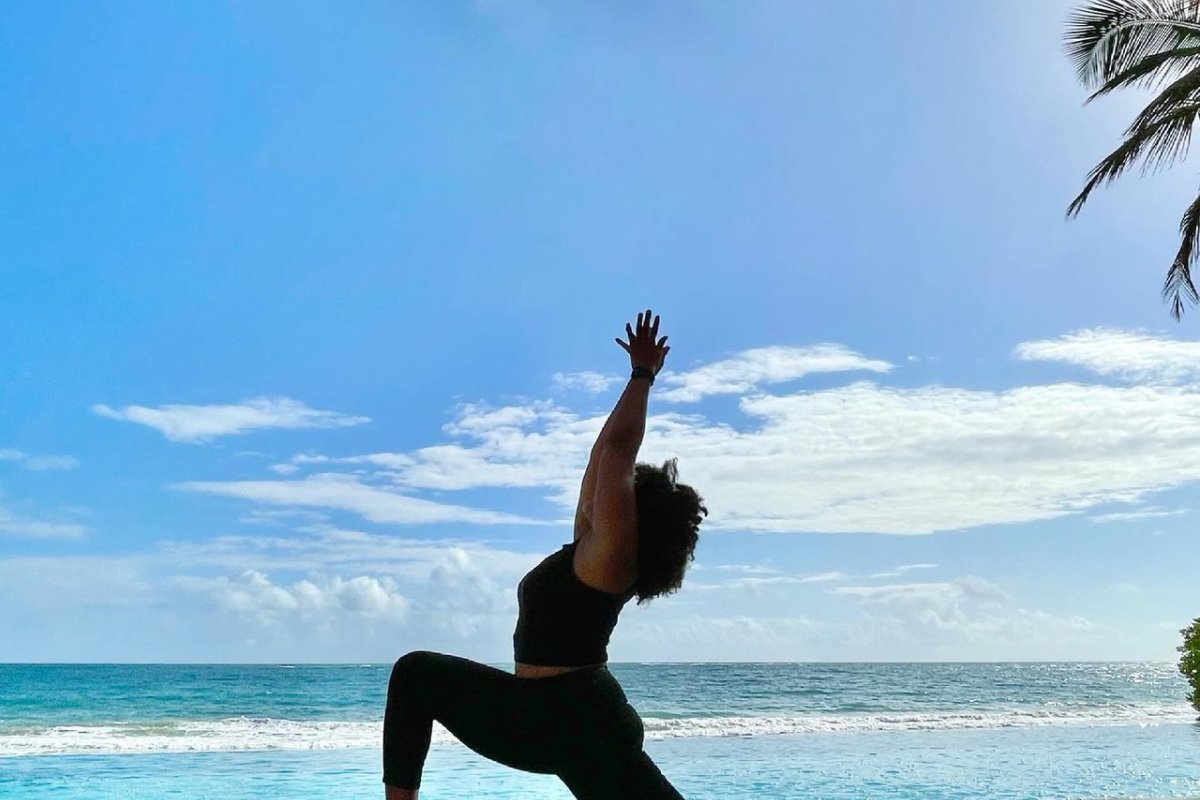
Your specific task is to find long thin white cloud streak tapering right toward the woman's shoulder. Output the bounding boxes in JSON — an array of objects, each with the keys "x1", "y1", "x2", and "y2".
[{"x1": 174, "y1": 473, "x2": 548, "y2": 525}]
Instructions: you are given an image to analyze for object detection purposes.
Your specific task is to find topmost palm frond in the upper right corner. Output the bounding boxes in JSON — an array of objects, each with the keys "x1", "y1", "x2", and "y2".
[{"x1": 1064, "y1": 0, "x2": 1200, "y2": 88}]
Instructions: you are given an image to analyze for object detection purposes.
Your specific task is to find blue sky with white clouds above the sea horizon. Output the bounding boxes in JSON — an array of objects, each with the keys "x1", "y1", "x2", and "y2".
[{"x1": 0, "y1": 0, "x2": 1200, "y2": 663}]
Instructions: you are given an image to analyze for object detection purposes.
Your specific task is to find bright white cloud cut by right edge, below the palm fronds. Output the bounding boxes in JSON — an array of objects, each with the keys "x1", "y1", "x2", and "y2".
[{"x1": 1015, "y1": 327, "x2": 1200, "y2": 383}]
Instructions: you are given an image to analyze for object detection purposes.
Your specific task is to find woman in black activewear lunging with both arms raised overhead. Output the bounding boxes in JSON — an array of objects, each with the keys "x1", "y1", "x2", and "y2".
[{"x1": 383, "y1": 309, "x2": 708, "y2": 800}]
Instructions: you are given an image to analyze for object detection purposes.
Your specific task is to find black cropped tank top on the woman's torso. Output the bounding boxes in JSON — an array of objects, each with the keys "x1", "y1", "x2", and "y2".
[{"x1": 512, "y1": 542, "x2": 634, "y2": 667}]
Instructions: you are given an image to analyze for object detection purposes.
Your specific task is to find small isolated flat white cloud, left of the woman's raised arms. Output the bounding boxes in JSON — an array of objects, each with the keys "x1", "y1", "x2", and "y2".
[{"x1": 92, "y1": 397, "x2": 371, "y2": 443}]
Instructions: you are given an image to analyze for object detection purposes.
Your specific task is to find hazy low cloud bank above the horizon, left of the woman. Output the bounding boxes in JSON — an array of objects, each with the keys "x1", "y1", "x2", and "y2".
[{"x1": 0, "y1": 525, "x2": 546, "y2": 661}]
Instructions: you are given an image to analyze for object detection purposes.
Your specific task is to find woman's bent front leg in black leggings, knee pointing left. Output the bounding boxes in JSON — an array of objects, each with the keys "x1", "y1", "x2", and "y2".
[{"x1": 383, "y1": 650, "x2": 574, "y2": 789}]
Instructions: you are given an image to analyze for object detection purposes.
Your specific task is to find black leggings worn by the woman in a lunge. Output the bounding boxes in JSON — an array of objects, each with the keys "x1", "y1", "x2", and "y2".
[{"x1": 383, "y1": 650, "x2": 683, "y2": 800}]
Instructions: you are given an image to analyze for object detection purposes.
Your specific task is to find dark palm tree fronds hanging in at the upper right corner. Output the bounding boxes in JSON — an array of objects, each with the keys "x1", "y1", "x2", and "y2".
[{"x1": 1064, "y1": 0, "x2": 1200, "y2": 320}]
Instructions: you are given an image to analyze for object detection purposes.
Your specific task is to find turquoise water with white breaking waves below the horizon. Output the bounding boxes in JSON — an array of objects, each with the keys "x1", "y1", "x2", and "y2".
[{"x1": 0, "y1": 663, "x2": 1200, "y2": 800}]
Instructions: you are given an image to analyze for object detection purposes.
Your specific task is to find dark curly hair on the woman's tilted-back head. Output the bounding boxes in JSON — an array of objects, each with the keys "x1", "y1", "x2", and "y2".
[{"x1": 634, "y1": 458, "x2": 708, "y2": 606}]
